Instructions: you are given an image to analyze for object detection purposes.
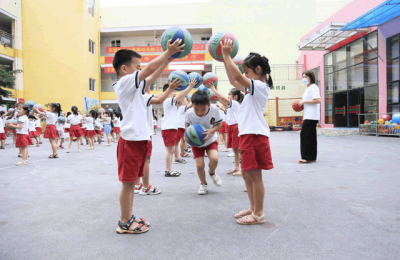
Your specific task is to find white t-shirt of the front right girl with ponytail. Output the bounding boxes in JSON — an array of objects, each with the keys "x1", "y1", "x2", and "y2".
[{"x1": 238, "y1": 79, "x2": 270, "y2": 137}]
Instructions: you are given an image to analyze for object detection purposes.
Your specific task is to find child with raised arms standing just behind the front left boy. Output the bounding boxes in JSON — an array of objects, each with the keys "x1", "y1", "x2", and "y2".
[{"x1": 161, "y1": 80, "x2": 196, "y2": 177}]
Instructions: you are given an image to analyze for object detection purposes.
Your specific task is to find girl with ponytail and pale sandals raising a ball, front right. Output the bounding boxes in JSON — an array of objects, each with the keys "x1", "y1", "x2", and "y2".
[{"x1": 221, "y1": 40, "x2": 273, "y2": 225}]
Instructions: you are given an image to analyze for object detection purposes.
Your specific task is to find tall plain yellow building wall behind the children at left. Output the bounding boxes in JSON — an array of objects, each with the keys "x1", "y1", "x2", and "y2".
[{"x1": 22, "y1": 0, "x2": 100, "y2": 111}]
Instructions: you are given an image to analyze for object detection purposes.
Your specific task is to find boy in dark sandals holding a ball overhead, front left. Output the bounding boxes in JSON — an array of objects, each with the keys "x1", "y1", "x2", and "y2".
[{"x1": 113, "y1": 39, "x2": 185, "y2": 234}]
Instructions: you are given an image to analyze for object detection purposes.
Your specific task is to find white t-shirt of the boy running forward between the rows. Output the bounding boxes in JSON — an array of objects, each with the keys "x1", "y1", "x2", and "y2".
[{"x1": 185, "y1": 104, "x2": 222, "y2": 147}]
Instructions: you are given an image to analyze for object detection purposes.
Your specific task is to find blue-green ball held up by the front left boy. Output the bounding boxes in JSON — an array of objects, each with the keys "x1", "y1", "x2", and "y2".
[{"x1": 161, "y1": 26, "x2": 193, "y2": 59}]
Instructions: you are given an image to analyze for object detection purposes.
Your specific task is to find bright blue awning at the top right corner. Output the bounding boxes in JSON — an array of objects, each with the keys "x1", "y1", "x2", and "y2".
[{"x1": 339, "y1": 0, "x2": 400, "y2": 31}]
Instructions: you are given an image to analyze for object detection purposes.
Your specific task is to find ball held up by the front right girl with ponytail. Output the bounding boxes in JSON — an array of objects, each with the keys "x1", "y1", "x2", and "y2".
[{"x1": 207, "y1": 31, "x2": 239, "y2": 61}]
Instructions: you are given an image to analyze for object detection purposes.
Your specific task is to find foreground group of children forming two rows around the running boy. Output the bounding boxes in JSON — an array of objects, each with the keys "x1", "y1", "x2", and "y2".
[{"x1": 113, "y1": 39, "x2": 273, "y2": 234}]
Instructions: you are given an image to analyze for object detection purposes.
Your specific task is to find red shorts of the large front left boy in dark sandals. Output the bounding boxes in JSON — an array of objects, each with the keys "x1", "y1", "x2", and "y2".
[{"x1": 117, "y1": 138, "x2": 148, "y2": 182}]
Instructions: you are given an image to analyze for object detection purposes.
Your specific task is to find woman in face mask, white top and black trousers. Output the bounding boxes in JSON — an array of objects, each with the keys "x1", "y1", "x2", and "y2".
[{"x1": 299, "y1": 70, "x2": 321, "y2": 163}]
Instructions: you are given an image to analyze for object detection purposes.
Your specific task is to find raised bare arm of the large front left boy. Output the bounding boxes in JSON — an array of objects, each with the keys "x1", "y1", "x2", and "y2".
[{"x1": 139, "y1": 39, "x2": 185, "y2": 82}]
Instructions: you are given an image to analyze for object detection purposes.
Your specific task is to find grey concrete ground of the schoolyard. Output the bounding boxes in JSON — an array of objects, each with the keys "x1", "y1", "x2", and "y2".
[{"x1": 0, "y1": 132, "x2": 400, "y2": 260}]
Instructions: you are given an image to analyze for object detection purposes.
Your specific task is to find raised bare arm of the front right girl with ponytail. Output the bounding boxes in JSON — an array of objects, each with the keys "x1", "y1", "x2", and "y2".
[{"x1": 221, "y1": 40, "x2": 250, "y2": 92}]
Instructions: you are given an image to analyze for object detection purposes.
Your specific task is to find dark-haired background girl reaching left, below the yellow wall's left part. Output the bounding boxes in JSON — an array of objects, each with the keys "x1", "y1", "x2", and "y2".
[{"x1": 34, "y1": 103, "x2": 61, "y2": 159}]
